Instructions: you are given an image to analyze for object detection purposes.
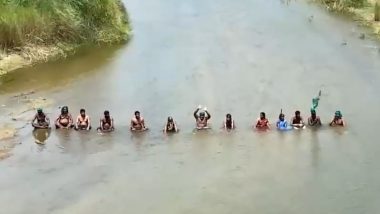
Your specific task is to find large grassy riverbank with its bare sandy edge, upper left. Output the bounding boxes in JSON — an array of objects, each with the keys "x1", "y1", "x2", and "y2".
[{"x1": 0, "y1": 0, "x2": 131, "y2": 76}]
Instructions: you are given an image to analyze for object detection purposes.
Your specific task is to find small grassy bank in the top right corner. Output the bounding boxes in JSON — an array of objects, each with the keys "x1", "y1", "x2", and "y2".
[{"x1": 318, "y1": 0, "x2": 380, "y2": 38}]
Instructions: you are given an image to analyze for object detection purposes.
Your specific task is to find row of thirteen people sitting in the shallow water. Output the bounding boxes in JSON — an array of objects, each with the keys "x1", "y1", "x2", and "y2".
[{"x1": 32, "y1": 106, "x2": 345, "y2": 132}]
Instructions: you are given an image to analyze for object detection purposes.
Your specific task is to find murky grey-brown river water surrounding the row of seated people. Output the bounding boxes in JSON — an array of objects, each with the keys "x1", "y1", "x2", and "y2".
[{"x1": 0, "y1": 0, "x2": 380, "y2": 214}]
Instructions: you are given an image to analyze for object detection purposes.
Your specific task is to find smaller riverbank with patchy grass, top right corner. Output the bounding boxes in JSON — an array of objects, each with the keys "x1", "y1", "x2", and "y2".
[{"x1": 318, "y1": 0, "x2": 380, "y2": 38}]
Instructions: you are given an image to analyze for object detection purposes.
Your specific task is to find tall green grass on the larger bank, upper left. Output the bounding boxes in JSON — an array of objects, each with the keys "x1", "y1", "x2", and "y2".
[{"x1": 0, "y1": 0, "x2": 130, "y2": 49}]
